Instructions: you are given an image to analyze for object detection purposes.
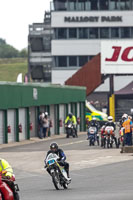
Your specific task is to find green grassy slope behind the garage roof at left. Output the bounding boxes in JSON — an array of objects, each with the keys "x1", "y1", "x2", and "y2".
[{"x1": 0, "y1": 58, "x2": 28, "y2": 82}]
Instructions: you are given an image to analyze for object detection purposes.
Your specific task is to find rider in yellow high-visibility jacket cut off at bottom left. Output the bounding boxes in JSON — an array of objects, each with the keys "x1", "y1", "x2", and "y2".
[{"x1": 0, "y1": 158, "x2": 17, "y2": 199}]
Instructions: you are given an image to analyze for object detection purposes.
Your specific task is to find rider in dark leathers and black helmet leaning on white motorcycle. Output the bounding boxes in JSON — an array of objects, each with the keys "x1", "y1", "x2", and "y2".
[{"x1": 44, "y1": 142, "x2": 71, "y2": 181}]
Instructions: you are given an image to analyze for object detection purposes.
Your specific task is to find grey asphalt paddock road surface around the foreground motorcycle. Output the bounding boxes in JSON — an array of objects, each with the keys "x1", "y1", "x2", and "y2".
[{"x1": 0, "y1": 134, "x2": 133, "y2": 200}]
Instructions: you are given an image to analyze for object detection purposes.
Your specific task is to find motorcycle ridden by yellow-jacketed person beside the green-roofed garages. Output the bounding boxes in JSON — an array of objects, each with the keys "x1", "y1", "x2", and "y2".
[{"x1": 65, "y1": 121, "x2": 76, "y2": 138}]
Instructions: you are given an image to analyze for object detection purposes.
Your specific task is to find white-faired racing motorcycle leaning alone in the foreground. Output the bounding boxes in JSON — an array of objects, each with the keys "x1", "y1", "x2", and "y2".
[{"x1": 46, "y1": 153, "x2": 71, "y2": 190}]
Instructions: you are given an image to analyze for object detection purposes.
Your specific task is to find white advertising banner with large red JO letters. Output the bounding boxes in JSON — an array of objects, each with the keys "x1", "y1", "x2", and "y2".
[{"x1": 101, "y1": 40, "x2": 133, "y2": 74}]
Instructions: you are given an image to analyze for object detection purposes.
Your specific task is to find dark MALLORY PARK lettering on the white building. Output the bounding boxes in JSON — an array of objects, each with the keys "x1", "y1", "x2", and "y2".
[{"x1": 64, "y1": 16, "x2": 123, "y2": 22}]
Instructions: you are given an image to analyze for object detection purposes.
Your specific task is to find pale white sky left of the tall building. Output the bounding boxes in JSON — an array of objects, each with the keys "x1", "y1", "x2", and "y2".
[{"x1": 0, "y1": 0, "x2": 51, "y2": 50}]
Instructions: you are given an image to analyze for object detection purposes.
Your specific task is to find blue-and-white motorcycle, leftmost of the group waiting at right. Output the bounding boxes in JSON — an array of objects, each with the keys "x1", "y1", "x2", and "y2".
[{"x1": 88, "y1": 126, "x2": 97, "y2": 146}]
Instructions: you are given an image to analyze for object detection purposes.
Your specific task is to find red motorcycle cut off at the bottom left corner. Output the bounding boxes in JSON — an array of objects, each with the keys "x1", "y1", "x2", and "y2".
[{"x1": 0, "y1": 171, "x2": 20, "y2": 200}]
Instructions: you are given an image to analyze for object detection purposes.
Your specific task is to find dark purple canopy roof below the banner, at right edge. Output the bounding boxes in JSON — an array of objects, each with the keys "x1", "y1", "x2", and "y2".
[{"x1": 115, "y1": 81, "x2": 133, "y2": 95}]
